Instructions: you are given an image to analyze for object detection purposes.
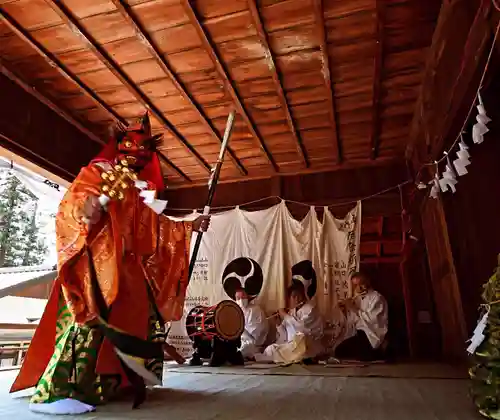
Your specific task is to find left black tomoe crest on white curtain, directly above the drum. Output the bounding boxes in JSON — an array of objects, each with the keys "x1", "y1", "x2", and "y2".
[{"x1": 222, "y1": 257, "x2": 264, "y2": 300}]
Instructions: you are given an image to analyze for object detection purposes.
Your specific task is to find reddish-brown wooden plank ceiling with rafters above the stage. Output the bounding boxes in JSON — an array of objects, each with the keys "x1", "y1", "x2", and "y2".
[{"x1": 0, "y1": 0, "x2": 441, "y2": 186}]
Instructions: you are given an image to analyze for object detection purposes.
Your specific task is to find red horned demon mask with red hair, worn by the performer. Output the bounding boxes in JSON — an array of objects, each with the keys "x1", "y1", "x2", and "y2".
[{"x1": 94, "y1": 113, "x2": 164, "y2": 191}]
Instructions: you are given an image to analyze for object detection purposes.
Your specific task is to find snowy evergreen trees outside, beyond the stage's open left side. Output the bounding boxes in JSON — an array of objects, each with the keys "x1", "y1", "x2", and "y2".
[{"x1": 0, "y1": 173, "x2": 47, "y2": 267}]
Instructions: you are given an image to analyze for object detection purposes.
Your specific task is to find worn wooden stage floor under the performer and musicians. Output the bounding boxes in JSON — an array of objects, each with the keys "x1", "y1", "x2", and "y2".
[{"x1": 0, "y1": 364, "x2": 478, "y2": 420}]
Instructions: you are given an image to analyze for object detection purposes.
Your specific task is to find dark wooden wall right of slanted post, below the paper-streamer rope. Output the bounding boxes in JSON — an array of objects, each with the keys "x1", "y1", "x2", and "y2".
[{"x1": 443, "y1": 74, "x2": 500, "y2": 332}]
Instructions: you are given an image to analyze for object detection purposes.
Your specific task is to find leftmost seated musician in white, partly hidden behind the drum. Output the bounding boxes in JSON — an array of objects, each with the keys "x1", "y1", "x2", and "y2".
[{"x1": 235, "y1": 287, "x2": 269, "y2": 360}]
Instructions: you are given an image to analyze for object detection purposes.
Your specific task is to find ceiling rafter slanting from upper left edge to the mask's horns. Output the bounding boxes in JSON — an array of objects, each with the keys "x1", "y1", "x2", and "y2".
[{"x1": 0, "y1": 8, "x2": 126, "y2": 124}]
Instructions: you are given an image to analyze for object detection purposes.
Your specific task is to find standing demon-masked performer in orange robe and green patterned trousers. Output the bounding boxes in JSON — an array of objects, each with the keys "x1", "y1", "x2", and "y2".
[{"x1": 11, "y1": 114, "x2": 209, "y2": 414}]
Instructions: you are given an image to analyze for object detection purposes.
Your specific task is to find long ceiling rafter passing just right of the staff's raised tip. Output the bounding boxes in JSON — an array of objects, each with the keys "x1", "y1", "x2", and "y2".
[{"x1": 182, "y1": 0, "x2": 279, "y2": 172}]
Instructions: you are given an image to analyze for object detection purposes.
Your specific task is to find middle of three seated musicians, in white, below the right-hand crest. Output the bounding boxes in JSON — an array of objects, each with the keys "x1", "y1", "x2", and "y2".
[{"x1": 255, "y1": 283, "x2": 324, "y2": 363}]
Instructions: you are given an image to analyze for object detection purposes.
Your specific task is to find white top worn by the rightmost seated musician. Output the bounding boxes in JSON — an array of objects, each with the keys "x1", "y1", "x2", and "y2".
[{"x1": 335, "y1": 289, "x2": 389, "y2": 349}]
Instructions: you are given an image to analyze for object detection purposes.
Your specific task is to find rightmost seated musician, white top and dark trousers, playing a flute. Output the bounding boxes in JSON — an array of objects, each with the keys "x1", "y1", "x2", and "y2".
[{"x1": 335, "y1": 273, "x2": 388, "y2": 361}]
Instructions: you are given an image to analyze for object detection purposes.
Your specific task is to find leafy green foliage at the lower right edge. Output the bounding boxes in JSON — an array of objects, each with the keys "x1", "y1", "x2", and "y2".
[{"x1": 469, "y1": 256, "x2": 500, "y2": 420}]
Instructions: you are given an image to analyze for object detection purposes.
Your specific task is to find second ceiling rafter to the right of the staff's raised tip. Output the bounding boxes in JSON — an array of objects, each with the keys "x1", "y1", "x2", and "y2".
[{"x1": 248, "y1": 0, "x2": 309, "y2": 168}]
